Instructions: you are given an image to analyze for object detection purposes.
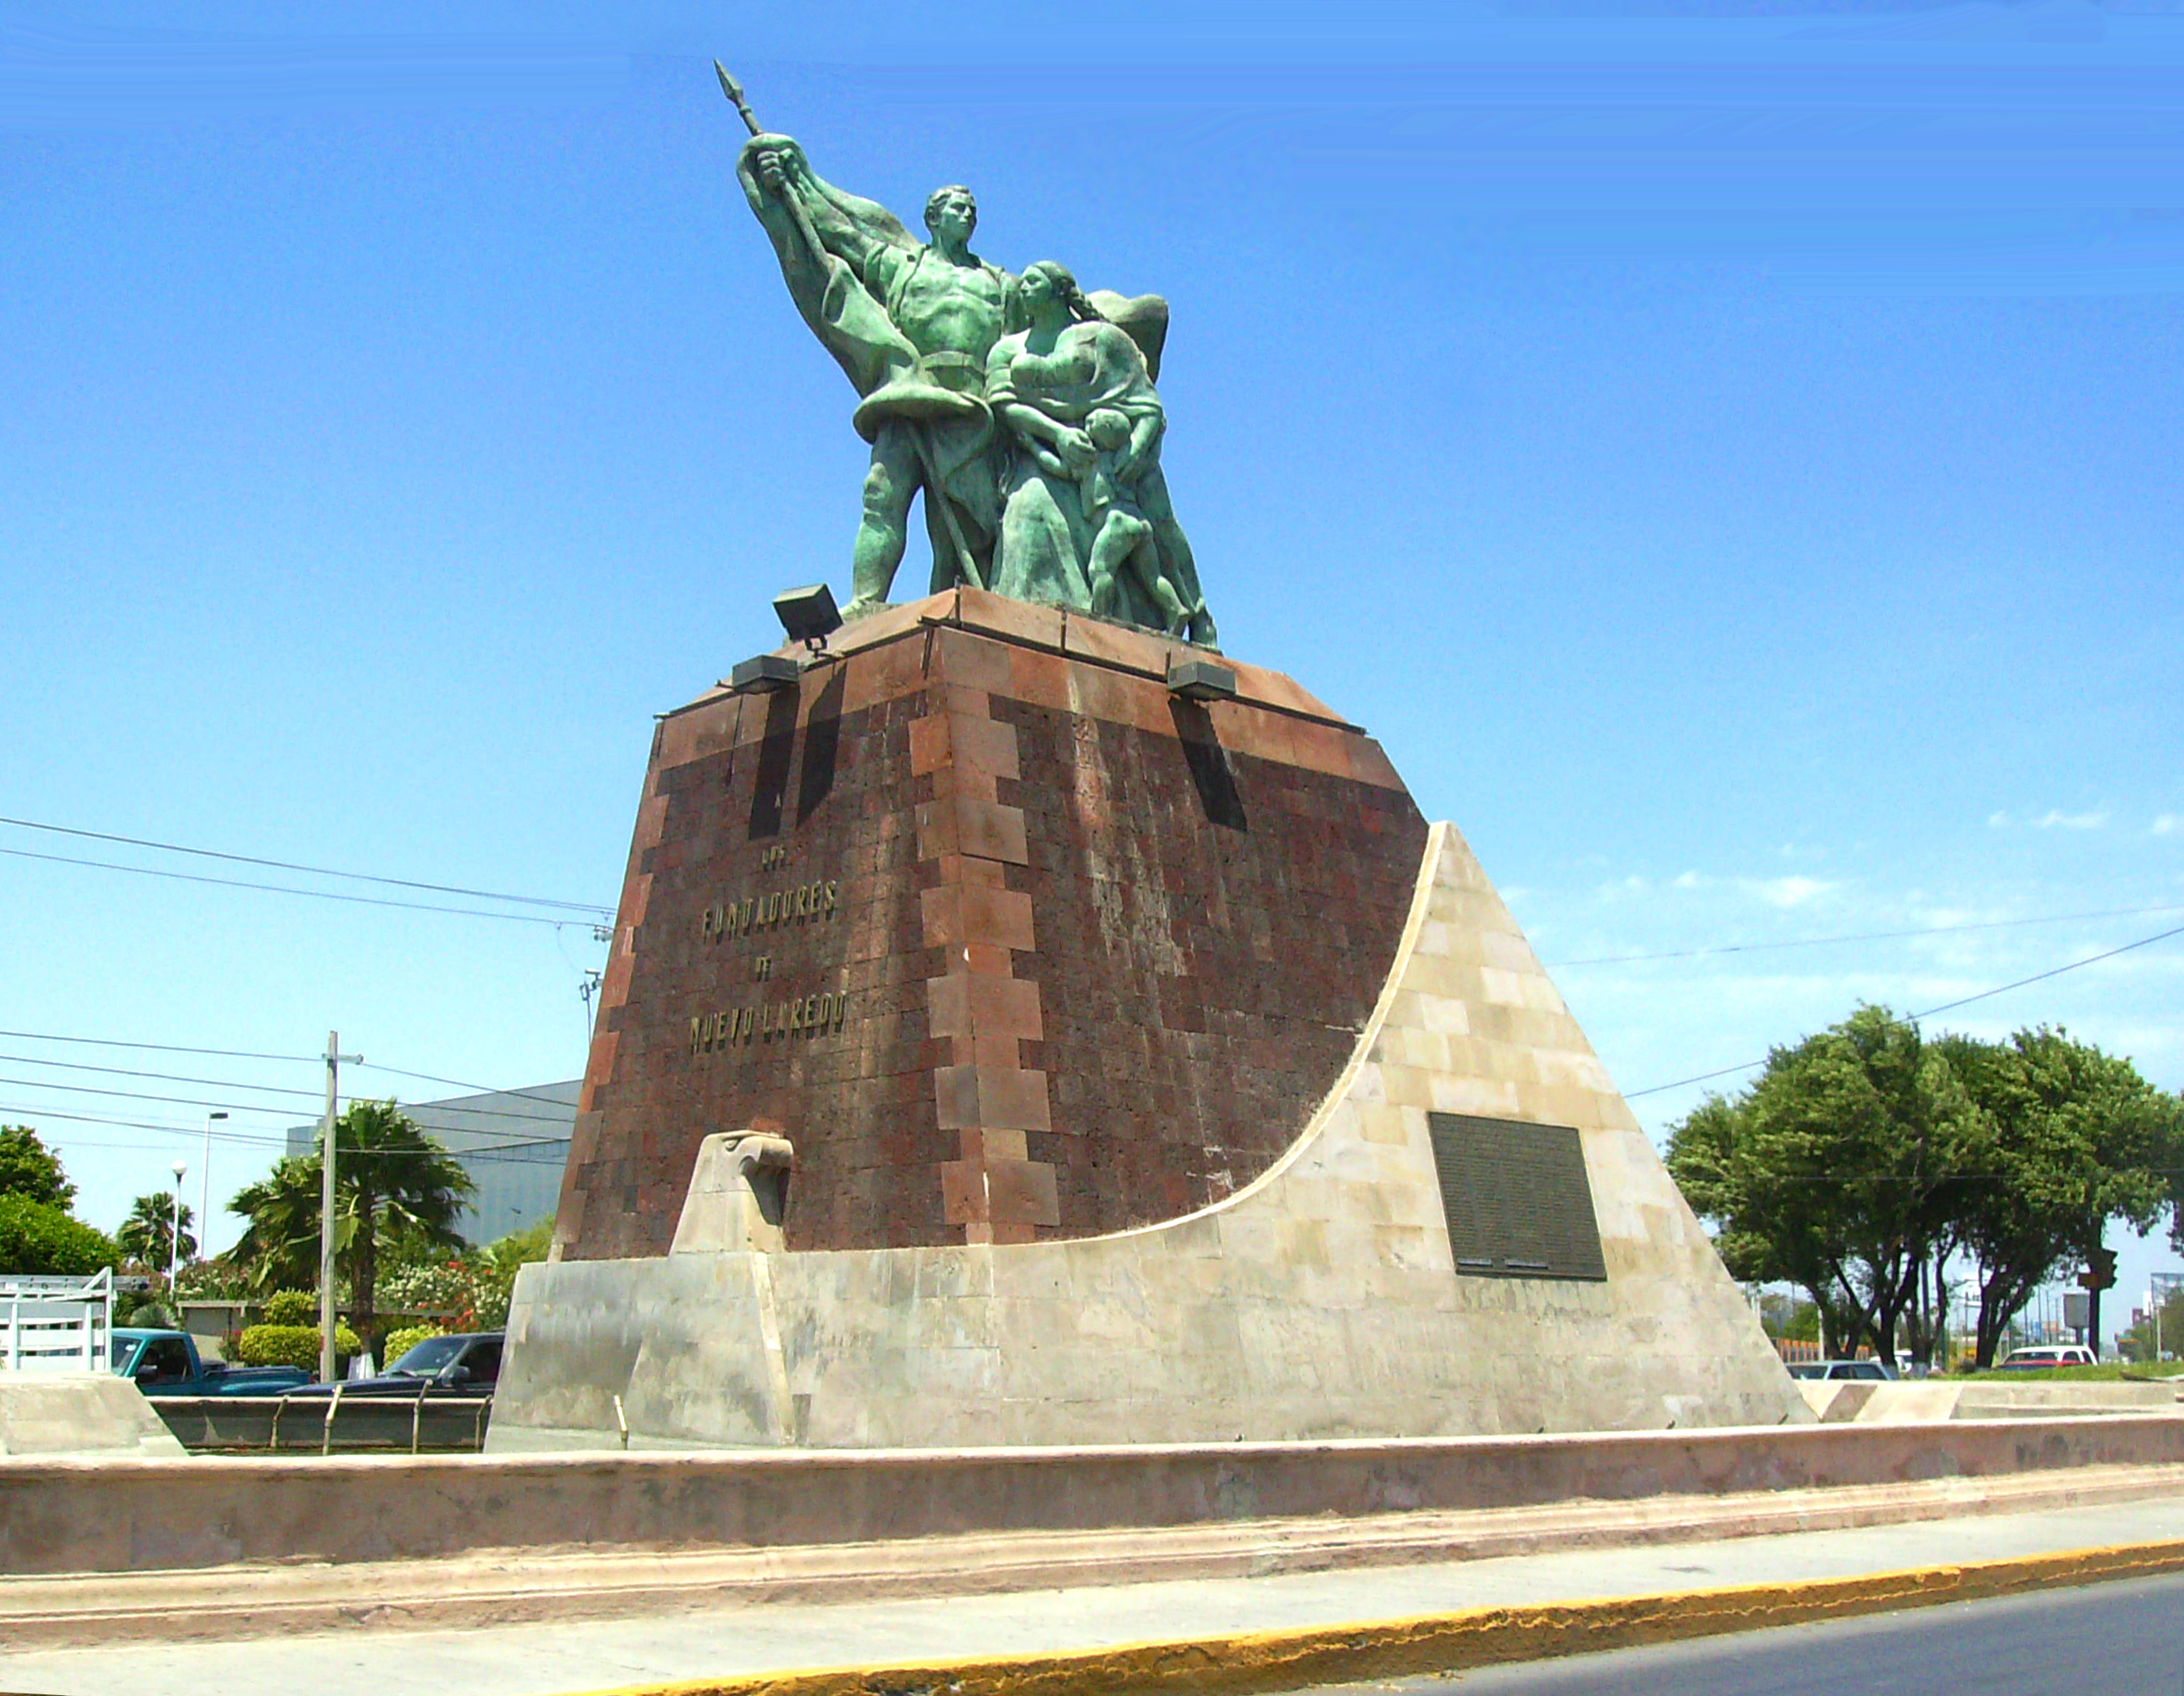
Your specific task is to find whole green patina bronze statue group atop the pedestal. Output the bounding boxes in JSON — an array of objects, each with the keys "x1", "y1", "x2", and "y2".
[{"x1": 721, "y1": 70, "x2": 1216, "y2": 646}]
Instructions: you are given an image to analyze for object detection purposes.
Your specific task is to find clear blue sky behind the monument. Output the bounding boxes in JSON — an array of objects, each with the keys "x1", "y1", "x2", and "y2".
[{"x1": 0, "y1": 4, "x2": 2184, "y2": 1344}]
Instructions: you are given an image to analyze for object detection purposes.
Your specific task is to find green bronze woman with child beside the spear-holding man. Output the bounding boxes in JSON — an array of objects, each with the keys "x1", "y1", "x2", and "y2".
[{"x1": 985, "y1": 260, "x2": 1216, "y2": 646}]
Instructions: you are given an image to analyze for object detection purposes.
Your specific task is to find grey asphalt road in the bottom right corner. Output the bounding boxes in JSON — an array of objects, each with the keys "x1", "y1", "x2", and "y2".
[{"x1": 1311, "y1": 1576, "x2": 2184, "y2": 1696}]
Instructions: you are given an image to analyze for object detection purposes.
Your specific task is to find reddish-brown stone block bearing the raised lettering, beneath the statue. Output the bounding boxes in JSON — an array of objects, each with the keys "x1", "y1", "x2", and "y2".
[{"x1": 555, "y1": 590, "x2": 1426, "y2": 1259}]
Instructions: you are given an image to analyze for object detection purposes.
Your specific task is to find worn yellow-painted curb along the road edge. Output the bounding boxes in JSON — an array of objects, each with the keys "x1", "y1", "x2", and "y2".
[{"x1": 567, "y1": 1541, "x2": 2184, "y2": 1696}]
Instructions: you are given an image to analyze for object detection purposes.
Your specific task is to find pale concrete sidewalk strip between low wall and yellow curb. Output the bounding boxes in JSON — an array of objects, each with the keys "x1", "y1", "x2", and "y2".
[{"x1": 13, "y1": 1495, "x2": 2184, "y2": 1696}]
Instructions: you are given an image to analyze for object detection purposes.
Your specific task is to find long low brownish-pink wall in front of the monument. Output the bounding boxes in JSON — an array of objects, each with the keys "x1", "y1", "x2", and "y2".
[{"x1": 0, "y1": 1414, "x2": 2184, "y2": 1578}]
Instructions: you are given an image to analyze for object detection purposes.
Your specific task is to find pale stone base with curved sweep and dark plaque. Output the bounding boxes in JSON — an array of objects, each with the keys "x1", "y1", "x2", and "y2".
[{"x1": 487, "y1": 825, "x2": 1815, "y2": 1453}]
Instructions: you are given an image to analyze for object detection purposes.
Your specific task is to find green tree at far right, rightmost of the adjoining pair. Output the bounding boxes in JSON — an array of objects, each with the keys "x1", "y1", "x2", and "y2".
[{"x1": 1937, "y1": 1026, "x2": 2184, "y2": 1367}]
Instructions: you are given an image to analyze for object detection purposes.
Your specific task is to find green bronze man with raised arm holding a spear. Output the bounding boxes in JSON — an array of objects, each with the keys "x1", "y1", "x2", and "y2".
[{"x1": 736, "y1": 135, "x2": 1015, "y2": 618}]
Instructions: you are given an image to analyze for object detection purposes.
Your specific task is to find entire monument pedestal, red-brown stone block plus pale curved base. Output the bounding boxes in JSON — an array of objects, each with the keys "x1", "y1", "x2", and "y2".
[{"x1": 489, "y1": 591, "x2": 1813, "y2": 1449}]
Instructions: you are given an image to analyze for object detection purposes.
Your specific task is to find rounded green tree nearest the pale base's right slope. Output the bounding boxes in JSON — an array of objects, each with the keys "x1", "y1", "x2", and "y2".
[{"x1": 1669, "y1": 1006, "x2": 1974, "y2": 1357}]
